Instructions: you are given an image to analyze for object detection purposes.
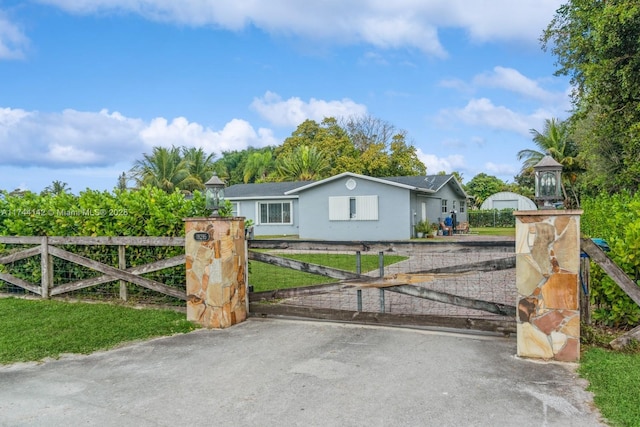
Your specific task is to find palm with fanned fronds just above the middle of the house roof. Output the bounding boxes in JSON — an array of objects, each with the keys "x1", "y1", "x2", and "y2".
[{"x1": 277, "y1": 145, "x2": 331, "y2": 181}]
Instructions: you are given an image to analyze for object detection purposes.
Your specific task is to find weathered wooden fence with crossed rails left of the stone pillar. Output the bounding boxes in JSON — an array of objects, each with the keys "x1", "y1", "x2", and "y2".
[{"x1": 0, "y1": 236, "x2": 186, "y2": 300}]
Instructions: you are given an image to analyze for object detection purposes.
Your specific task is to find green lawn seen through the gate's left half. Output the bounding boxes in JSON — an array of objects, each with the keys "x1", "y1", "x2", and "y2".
[{"x1": 249, "y1": 254, "x2": 407, "y2": 292}]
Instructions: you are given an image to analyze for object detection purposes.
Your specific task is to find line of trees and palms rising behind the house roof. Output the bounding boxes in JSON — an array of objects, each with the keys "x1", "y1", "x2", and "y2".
[{"x1": 123, "y1": 116, "x2": 426, "y2": 192}]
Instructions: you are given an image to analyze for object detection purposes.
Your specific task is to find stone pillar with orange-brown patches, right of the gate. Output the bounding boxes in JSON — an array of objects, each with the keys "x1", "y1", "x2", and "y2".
[{"x1": 514, "y1": 210, "x2": 582, "y2": 362}]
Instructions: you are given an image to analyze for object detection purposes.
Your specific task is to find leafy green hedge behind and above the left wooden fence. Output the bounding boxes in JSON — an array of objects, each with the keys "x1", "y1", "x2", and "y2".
[{"x1": 0, "y1": 187, "x2": 210, "y2": 300}]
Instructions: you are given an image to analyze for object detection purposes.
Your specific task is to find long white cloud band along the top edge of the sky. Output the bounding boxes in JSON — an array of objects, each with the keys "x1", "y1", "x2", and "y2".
[{"x1": 40, "y1": 0, "x2": 562, "y2": 56}]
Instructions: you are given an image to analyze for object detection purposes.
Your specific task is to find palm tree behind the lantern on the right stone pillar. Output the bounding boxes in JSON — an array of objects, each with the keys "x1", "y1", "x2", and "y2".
[{"x1": 517, "y1": 118, "x2": 583, "y2": 207}]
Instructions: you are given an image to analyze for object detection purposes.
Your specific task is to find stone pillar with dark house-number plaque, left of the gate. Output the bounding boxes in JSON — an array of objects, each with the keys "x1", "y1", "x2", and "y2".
[{"x1": 185, "y1": 217, "x2": 247, "y2": 328}]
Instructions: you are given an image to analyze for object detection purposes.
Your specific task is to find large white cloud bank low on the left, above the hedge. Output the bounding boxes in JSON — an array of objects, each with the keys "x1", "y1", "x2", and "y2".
[{"x1": 0, "y1": 108, "x2": 278, "y2": 168}]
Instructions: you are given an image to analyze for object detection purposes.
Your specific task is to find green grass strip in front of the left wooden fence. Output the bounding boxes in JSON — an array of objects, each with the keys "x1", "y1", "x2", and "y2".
[{"x1": 0, "y1": 298, "x2": 198, "y2": 364}]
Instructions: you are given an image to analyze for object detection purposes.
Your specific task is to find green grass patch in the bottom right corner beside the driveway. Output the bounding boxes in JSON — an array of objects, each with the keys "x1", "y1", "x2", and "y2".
[{"x1": 578, "y1": 346, "x2": 640, "y2": 426}]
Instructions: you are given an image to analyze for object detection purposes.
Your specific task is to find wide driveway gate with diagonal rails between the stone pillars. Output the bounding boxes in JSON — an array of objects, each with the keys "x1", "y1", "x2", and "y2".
[{"x1": 249, "y1": 241, "x2": 516, "y2": 334}]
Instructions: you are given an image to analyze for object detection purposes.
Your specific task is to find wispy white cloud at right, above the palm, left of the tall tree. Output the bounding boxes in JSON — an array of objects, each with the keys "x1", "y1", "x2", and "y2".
[{"x1": 438, "y1": 98, "x2": 552, "y2": 135}]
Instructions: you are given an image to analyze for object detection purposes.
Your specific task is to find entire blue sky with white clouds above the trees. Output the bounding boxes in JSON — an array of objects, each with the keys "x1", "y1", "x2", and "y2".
[{"x1": 0, "y1": 0, "x2": 571, "y2": 193}]
